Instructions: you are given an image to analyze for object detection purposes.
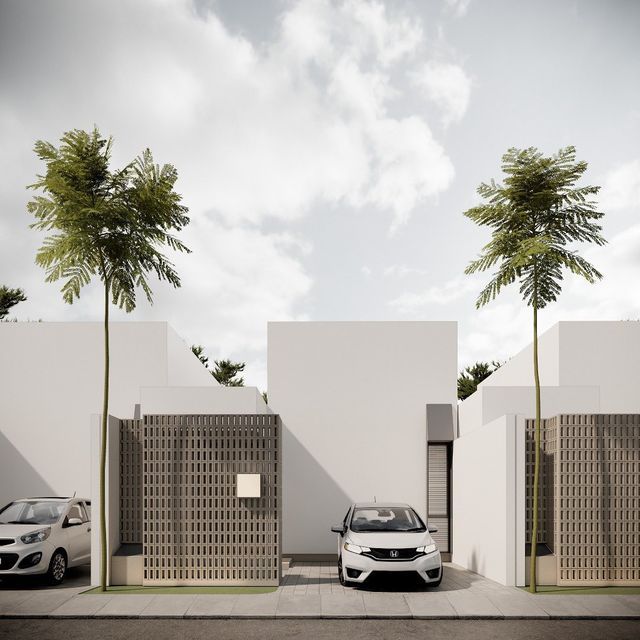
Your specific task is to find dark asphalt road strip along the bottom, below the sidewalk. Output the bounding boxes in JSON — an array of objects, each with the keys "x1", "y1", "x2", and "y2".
[{"x1": 0, "y1": 619, "x2": 640, "y2": 640}]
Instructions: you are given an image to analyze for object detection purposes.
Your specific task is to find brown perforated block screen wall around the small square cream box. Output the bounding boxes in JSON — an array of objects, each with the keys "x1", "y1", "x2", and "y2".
[{"x1": 121, "y1": 414, "x2": 282, "y2": 586}]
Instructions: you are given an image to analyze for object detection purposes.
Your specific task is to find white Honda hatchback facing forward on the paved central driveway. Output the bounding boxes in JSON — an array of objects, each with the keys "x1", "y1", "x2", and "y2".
[{"x1": 331, "y1": 502, "x2": 442, "y2": 587}]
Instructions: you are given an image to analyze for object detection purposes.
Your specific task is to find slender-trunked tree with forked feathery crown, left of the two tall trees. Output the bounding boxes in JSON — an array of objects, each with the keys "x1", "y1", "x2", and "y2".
[{"x1": 27, "y1": 128, "x2": 189, "y2": 591}]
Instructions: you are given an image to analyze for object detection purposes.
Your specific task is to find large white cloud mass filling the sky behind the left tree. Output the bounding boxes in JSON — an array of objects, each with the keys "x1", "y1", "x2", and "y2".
[{"x1": 0, "y1": 0, "x2": 470, "y2": 378}]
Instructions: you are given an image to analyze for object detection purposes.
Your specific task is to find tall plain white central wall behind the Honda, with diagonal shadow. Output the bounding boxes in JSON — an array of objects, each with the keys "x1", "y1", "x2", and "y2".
[{"x1": 268, "y1": 322, "x2": 457, "y2": 554}]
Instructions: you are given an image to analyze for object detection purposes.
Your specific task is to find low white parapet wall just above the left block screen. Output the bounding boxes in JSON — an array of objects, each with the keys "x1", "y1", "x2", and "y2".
[{"x1": 140, "y1": 385, "x2": 269, "y2": 415}]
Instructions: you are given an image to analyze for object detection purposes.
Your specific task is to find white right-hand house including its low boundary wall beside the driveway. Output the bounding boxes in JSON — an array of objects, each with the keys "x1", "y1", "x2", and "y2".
[{"x1": 453, "y1": 321, "x2": 640, "y2": 585}]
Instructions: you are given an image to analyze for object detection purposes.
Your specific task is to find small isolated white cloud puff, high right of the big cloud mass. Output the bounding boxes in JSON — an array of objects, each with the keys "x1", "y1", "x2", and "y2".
[{"x1": 411, "y1": 60, "x2": 471, "y2": 126}]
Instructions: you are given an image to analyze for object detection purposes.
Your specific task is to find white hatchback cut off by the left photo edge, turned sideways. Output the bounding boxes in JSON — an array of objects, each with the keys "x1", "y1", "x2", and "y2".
[{"x1": 0, "y1": 498, "x2": 91, "y2": 584}]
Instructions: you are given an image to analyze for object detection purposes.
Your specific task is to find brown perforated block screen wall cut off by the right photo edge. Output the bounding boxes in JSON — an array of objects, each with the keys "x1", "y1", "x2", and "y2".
[{"x1": 527, "y1": 414, "x2": 640, "y2": 586}]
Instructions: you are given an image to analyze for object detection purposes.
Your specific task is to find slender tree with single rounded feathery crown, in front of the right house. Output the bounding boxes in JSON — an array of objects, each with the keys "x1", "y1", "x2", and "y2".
[{"x1": 464, "y1": 147, "x2": 606, "y2": 592}]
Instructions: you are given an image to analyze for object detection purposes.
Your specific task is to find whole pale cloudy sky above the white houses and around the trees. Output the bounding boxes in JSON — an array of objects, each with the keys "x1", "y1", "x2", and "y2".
[{"x1": 0, "y1": 0, "x2": 640, "y2": 390}]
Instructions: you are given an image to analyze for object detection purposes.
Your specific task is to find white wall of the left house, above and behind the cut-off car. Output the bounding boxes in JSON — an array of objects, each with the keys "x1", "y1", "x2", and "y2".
[{"x1": 0, "y1": 322, "x2": 217, "y2": 504}]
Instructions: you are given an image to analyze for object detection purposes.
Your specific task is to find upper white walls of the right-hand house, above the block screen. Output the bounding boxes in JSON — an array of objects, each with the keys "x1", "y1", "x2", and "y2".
[{"x1": 458, "y1": 321, "x2": 640, "y2": 435}]
